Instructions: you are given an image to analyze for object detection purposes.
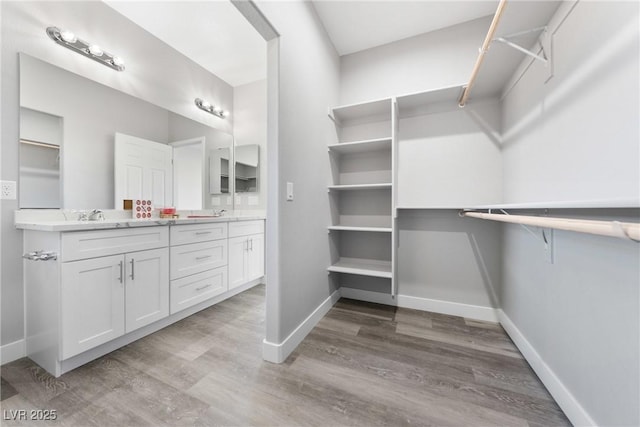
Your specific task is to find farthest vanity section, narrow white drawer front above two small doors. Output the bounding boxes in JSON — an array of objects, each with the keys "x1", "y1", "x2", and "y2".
[{"x1": 229, "y1": 220, "x2": 264, "y2": 289}]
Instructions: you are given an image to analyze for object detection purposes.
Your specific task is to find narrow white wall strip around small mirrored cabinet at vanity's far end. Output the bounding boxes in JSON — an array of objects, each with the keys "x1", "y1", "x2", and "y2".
[{"x1": 233, "y1": 80, "x2": 267, "y2": 210}]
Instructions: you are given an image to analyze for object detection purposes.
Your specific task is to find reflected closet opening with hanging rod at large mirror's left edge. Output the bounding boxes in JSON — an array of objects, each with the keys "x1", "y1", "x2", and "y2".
[{"x1": 19, "y1": 107, "x2": 63, "y2": 209}]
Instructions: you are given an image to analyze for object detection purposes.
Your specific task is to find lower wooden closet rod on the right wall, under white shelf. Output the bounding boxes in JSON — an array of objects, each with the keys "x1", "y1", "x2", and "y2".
[{"x1": 461, "y1": 211, "x2": 640, "y2": 242}]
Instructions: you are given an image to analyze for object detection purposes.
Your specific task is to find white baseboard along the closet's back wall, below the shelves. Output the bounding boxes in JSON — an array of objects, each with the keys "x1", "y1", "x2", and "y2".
[{"x1": 340, "y1": 288, "x2": 498, "y2": 323}]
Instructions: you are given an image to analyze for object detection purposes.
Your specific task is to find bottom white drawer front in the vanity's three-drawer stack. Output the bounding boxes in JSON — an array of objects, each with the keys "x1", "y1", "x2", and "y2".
[{"x1": 170, "y1": 267, "x2": 227, "y2": 314}]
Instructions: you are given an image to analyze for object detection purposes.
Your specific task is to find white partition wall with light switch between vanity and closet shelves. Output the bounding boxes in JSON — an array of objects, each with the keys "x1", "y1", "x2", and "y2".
[{"x1": 258, "y1": 2, "x2": 339, "y2": 352}]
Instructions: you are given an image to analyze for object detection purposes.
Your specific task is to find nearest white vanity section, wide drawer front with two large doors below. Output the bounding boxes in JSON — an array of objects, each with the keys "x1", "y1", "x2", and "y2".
[{"x1": 60, "y1": 227, "x2": 169, "y2": 360}]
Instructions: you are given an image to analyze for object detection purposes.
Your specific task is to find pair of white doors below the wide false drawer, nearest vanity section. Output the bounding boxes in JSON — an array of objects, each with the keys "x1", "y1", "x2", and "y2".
[{"x1": 60, "y1": 248, "x2": 169, "y2": 359}]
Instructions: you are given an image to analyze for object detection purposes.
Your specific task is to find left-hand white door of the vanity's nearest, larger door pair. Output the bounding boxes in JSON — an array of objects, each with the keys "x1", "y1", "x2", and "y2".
[{"x1": 61, "y1": 255, "x2": 125, "y2": 360}]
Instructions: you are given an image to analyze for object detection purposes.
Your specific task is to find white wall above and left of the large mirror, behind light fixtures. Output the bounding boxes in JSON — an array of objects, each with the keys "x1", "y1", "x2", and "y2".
[{"x1": 0, "y1": 1, "x2": 233, "y2": 352}]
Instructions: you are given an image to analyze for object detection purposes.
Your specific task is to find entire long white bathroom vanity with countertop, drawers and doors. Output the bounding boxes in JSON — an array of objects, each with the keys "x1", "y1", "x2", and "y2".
[{"x1": 16, "y1": 214, "x2": 264, "y2": 377}]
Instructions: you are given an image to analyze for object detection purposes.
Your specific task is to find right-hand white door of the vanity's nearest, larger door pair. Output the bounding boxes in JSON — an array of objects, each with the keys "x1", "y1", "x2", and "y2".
[{"x1": 125, "y1": 248, "x2": 169, "y2": 333}]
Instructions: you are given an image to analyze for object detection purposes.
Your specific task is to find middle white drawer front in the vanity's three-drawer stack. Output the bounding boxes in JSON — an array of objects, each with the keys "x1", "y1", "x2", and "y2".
[{"x1": 170, "y1": 239, "x2": 227, "y2": 280}]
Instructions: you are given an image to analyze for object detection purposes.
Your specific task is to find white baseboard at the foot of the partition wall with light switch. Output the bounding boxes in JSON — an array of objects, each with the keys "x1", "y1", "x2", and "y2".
[{"x1": 262, "y1": 290, "x2": 340, "y2": 363}]
